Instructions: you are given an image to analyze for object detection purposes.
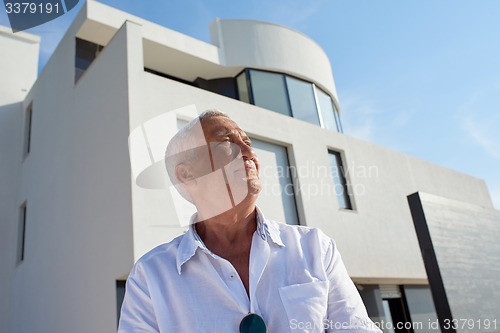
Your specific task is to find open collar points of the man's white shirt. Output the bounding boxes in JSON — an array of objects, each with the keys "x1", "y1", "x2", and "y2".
[{"x1": 176, "y1": 207, "x2": 285, "y2": 275}]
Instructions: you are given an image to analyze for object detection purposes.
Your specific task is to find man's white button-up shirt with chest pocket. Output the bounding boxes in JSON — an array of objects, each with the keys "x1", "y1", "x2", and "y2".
[{"x1": 118, "y1": 209, "x2": 381, "y2": 333}]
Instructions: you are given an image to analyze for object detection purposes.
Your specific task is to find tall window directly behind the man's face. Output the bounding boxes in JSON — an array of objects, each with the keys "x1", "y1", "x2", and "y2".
[{"x1": 252, "y1": 138, "x2": 299, "y2": 224}]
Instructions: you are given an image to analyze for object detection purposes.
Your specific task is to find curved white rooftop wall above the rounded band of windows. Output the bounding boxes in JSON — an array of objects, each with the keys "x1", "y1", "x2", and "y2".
[{"x1": 210, "y1": 19, "x2": 338, "y2": 106}]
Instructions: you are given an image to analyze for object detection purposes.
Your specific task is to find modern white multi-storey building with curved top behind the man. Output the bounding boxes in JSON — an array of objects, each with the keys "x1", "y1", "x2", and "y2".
[{"x1": 0, "y1": 1, "x2": 500, "y2": 333}]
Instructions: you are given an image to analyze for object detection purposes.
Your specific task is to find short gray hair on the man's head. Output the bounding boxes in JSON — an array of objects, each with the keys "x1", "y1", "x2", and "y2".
[{"x1": 165, "y1": 109, "x2": 229, "y2": 203}]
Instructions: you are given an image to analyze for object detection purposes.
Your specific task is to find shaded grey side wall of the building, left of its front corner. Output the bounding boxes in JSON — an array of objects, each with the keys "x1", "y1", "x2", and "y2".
[{"x1": 5, "y1": 11, "x2": 133, "y2": 333}]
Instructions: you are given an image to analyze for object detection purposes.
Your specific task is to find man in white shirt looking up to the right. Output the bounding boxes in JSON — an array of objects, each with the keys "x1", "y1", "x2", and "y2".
[{"x1": 118, "y1": 111, "x2": 380, "y2": 333}]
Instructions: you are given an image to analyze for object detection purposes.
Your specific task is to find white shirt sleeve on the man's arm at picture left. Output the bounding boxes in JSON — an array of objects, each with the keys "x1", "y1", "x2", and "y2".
[{"x1": 118, "y1": 263, "x2": 160, "y2": 333}]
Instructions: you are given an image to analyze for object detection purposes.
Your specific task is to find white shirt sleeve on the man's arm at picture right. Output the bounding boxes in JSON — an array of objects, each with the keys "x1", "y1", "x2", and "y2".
[{"x1": 324, "y1": 240, "x2": 382, "y2": 333}]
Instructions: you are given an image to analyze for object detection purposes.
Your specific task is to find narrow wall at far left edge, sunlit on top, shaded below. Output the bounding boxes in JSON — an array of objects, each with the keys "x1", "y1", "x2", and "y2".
[{"x1": 0, "y1": 27, "x2": 40, "y2": 332}]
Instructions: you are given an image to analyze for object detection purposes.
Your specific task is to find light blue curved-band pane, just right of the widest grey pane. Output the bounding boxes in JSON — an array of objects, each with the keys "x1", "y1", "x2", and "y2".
[{"x1": 286, "y1": 76, "x2": 320, "y2": 126}]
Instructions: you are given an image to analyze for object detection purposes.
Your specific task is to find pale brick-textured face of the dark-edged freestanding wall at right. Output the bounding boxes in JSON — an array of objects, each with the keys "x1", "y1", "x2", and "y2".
[{"x1": 412, "y1": 193, "x2": 500, "y2": 332}]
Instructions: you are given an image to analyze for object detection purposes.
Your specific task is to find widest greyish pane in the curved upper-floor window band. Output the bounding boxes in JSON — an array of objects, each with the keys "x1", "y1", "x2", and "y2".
[{"x1": 249, "y1": 70, "x2": 292, "y2": 116}]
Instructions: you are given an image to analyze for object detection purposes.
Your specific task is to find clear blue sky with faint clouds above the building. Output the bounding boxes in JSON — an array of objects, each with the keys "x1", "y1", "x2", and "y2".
[{"x1": 0, "y1": 0, "x2": 500, "y2": 209}]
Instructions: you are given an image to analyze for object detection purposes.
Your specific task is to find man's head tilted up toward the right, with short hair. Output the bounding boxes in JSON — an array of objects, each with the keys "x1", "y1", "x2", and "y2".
[{"x1": 165, "y1": 110, "x2": 261, "y2": 213}]
